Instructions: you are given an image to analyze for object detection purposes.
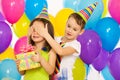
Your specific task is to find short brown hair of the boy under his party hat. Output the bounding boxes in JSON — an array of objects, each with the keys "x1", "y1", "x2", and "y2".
[{"x1": 68, "y1": 13, "x2": 85, "y2": 29}]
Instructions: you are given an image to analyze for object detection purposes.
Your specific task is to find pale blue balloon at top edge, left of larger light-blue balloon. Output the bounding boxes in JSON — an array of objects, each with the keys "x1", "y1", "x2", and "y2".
[{"x1": 63, "y1": 0, "x2": 80, "y2": 11}]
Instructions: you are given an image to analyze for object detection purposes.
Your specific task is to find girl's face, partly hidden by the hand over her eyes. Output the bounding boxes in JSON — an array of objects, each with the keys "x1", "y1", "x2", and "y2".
[{"x1": 31, "y1": 21, "x2": 45, "y2": 43}]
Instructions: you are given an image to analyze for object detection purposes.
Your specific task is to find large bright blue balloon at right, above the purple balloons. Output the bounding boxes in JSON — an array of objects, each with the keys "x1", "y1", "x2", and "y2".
[{"x1": 94, "y1": 17, "x2": 120, "y2": 51}]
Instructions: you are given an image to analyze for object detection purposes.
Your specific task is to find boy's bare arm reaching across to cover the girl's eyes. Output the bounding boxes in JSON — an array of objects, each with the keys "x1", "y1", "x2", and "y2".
[{"x1": 38, "y1": 25, "x2": 76, "y2": 56}]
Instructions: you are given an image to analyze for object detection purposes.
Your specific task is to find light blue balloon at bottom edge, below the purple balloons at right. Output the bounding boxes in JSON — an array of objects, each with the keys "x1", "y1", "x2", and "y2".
[{"x1": 101, "y1": 66, "x2": 115, "y2": 80}]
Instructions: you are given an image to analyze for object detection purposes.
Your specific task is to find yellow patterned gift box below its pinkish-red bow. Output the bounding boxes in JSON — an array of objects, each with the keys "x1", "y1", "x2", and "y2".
[{"x1": 16, "y1": 51, "x2": 40, "y2": 71}]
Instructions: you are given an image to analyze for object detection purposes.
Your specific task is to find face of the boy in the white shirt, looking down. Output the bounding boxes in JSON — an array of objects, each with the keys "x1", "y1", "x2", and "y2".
[{"x1": 65, "y1": 17, "x2": 81, "y2": 40}]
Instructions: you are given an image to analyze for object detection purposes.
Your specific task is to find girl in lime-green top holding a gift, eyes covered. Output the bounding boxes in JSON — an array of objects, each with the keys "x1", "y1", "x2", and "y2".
[{"x1": 16, "y1": 18, "x2": 56, "y2": 80}]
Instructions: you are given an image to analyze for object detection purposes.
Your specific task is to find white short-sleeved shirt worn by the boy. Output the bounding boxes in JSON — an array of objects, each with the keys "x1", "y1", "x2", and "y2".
[{"x1": 55, "y1": 37, "x2": 81, "y2": 80}]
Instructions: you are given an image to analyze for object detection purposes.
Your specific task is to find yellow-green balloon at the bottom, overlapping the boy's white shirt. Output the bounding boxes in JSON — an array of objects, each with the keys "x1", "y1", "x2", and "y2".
[{"x1": 72, "y1": 58, "x2": 86, "y2": 80}]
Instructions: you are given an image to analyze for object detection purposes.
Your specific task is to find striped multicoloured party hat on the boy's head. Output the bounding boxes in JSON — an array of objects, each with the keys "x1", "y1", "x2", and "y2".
[{"x1": 77, "y1": 2, "x2": 98, "y2": 22}]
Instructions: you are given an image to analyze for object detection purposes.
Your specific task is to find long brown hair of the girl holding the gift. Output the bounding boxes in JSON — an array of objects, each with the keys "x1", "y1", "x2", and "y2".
[{"x1": 28, "y1": 18, "x2": 54, "y2": 50}]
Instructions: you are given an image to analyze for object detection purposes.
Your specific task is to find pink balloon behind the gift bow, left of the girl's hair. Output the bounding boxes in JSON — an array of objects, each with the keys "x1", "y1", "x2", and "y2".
[{"x1": 14, "y1": 36, "x2": 27, "y2": 55}]
